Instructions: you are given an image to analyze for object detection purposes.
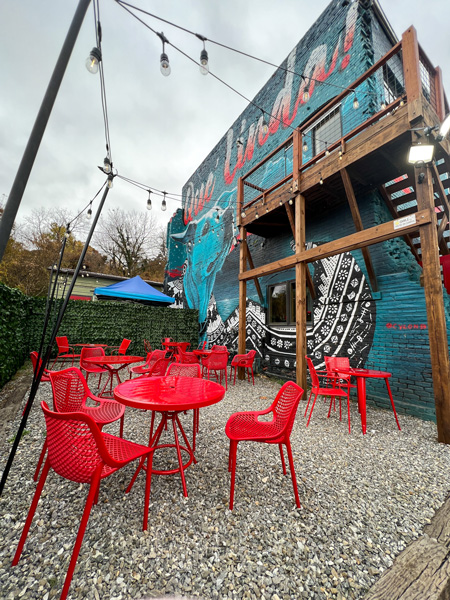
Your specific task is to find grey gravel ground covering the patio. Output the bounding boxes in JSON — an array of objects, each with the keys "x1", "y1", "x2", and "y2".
[{"x1": 0, "y1": 377, "x2": 450, "y2": 600}]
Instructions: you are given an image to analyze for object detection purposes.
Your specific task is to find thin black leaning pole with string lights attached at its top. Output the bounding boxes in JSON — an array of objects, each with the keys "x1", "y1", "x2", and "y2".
[{"x1": 0, "y1": 183, "x2": 113, "y2": 496}]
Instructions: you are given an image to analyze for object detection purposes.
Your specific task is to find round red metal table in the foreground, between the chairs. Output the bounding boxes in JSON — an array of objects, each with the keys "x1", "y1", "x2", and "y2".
[{"x1": 114, "y1": 376, "x2": 225, "y2": 497}]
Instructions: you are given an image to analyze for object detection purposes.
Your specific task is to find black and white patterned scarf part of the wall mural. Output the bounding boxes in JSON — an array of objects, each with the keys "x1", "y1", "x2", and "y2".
[{"x1": 169, "y1": 247, "x2": 376, "y2": 373}]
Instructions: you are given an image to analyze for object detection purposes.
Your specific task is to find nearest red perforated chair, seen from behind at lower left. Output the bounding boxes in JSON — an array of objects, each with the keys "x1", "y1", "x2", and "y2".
[{"x1": 12, "y1": 402, "x2": 154, "y2": 600}]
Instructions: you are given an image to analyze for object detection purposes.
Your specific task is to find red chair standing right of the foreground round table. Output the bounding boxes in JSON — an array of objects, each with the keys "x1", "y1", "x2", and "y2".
[{"x1": 225, "y1": 381, "x2": 303, "y2": 510}]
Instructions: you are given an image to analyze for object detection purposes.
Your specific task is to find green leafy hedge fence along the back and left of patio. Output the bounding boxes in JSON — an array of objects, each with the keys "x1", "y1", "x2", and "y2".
[{"x1": 0, "y1": 284, "x2": 199, "y2": 387}]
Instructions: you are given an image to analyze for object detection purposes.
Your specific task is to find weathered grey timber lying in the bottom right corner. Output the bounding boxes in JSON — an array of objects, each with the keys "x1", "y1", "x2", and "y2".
[{"x1": 364, "y1": 535, "x2": 450, "y2": 600}]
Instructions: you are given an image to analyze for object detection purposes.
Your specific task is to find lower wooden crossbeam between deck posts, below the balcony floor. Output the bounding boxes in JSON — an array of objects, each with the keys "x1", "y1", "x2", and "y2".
[{"x1": 239, "y1": 209, "x2": 431, "y2": 279}]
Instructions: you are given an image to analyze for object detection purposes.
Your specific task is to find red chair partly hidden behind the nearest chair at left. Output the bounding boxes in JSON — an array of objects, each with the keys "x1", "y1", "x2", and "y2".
[{"x1": 33, "y1": 367, "x2": 125, "y2": 481}]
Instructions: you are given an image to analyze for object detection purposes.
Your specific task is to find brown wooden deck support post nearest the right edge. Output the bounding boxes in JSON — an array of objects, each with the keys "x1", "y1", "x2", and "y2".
[{"x1": 415, "y1": 165, "x2": 450, "y2": 444}]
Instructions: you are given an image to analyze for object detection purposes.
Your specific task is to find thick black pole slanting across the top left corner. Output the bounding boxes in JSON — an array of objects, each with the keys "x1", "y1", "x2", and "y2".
[{"x1": 0, "y1": 0, "x2": 91, "y2": 262}]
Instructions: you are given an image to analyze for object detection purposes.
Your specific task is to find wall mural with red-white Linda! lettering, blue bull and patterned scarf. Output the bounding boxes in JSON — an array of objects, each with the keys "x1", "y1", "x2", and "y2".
[{"x1": 166, "y1": 1, "x2": 378, "y2": 360}]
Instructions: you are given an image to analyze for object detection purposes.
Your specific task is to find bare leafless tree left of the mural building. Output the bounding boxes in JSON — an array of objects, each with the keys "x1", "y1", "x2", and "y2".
[{"x1": 94, "y1": 208, "x2": 161, "y2": 277}]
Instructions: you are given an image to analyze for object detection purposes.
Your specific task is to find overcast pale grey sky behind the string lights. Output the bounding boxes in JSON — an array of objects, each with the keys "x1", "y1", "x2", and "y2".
[{"x1": 0, "y1": 0, "x2": 450, "y2": 238}]
